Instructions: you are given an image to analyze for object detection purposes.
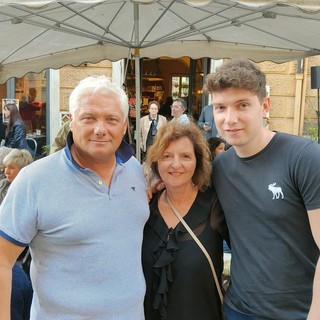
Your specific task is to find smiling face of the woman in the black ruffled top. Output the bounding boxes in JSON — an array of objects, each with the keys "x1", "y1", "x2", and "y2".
[{"x1": 158, "y1": 137, "x2": 196, "y2": 187}]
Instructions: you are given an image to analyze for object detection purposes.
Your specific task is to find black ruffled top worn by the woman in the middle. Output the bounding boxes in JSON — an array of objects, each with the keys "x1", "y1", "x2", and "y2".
[{"x1": 142, "y1": 190, "x2": 227, "y2": 320}]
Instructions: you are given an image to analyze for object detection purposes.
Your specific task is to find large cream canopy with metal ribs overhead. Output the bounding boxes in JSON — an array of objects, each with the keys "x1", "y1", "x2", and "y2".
[{"x1": 0, "y1": 0, "x2": 320, "y2": 83}]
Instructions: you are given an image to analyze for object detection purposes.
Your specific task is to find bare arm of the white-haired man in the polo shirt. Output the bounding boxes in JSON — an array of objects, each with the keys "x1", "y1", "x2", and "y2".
[{"x1": 0, "y1": 237, "x2": 24, "y2": 320}]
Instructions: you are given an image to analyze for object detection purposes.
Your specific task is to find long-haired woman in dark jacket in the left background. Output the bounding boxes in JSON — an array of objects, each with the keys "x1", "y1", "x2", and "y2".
[{"x1": 4, "y1": 103, "x2": 29, "y2": 150}]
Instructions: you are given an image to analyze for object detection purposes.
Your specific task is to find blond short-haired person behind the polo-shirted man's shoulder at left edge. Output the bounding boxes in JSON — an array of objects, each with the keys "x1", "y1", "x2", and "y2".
[{"x1": 0, "y1": 149, "x2": 33, "y2": 204}]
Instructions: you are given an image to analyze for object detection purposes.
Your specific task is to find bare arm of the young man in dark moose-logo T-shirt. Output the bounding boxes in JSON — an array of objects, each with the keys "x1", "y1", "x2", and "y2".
[{"x1": 307, "y1": 208, "x2": 320, "y2": 320}]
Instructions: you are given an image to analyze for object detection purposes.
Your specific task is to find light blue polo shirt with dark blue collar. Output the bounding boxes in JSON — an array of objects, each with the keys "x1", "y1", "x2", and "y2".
[{"x1": 0, "y1": 134, "x2": 149, "y2": 320}]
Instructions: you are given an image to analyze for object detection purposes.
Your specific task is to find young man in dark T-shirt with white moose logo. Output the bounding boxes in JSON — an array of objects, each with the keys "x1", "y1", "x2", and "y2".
[{"x1": 206, "y1": 60, "x2": 320, "y2": 320}]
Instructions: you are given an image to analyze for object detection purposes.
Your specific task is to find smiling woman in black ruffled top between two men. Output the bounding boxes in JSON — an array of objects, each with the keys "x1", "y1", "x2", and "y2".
[{"x1": 142, "y1": 122, "x2": 227, "y2": 320}]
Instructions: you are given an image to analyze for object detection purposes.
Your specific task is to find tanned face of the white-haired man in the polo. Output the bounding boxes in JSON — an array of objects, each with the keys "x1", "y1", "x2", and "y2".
[{"x1": 70, "y1": 93, "x2": 127, "y2": 165}]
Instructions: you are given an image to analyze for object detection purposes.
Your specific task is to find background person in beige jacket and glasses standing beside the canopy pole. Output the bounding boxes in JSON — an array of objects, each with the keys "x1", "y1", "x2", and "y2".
[{"x1": 140, "y1": 101, "x2": 167, "y2": 158}]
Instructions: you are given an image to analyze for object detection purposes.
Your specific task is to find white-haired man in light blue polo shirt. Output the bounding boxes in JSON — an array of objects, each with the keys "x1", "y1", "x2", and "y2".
[{"x1": 0, "y1": 77, "x2": 149, "y2": 320}]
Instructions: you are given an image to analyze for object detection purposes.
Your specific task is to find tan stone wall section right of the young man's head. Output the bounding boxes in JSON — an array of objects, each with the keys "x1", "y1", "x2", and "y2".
[{"x1": 259, "y1": 56, "x2": 320, "y2": 139}]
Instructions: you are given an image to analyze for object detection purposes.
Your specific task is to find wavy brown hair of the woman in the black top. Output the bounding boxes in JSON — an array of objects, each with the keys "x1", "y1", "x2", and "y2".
[{"x1": 146, "y1": 121, "x2": 211, "y2": 190}]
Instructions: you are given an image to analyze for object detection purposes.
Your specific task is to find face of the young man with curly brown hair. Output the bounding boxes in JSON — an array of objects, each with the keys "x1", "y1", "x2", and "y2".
[{"x1": 212, "y1": 88, "x2": 270, "y2": 158}]
